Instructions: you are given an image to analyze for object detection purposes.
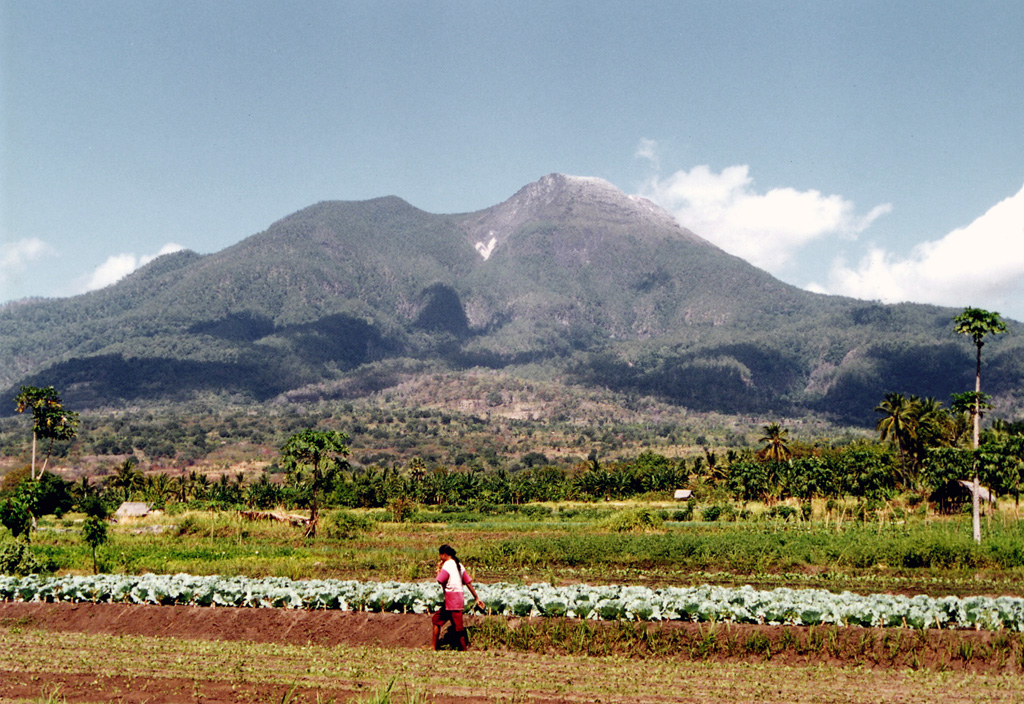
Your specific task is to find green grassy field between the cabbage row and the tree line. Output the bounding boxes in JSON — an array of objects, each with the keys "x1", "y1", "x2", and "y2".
[{"x1": 18, "y1": 503, "x2": 1024, "y2": 596}]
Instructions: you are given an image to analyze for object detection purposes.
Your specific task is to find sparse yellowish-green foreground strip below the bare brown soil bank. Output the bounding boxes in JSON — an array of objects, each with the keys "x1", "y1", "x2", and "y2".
[{"x1": 0, "y1": 625, "x2": 1024, "y2": 704}]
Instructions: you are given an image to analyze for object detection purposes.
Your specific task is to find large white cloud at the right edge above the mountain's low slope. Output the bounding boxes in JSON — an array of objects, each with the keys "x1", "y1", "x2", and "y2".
[{"x1": 813, "y1": 188, "x2": 1024, "y2": 319}]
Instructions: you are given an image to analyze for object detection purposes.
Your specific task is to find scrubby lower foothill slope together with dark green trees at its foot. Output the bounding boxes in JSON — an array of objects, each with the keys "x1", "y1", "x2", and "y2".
[{"x1": 0, "y1": 368, "x2": 1024, "y2": 532}]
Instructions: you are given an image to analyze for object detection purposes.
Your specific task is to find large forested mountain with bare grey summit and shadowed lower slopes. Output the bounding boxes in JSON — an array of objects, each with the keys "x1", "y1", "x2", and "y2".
[{"x1": 0, "y1": 174, "x2": 1024, "y2": 423}]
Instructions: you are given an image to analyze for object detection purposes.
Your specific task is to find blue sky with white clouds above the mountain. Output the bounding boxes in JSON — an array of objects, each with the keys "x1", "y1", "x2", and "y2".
[{"x1": 0, "y1": 0, "x2": 1024, "y2": 320}]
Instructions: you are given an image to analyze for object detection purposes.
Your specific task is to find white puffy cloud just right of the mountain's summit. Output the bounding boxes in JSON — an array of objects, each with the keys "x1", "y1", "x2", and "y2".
[{"x1": 637, "y1": 162, "x2": 892, "y2": 273}]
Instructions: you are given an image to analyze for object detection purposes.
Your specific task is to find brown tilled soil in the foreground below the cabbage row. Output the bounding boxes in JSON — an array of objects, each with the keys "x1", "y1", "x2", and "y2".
[{"x1": 0, "y1": 602, "x2": 1024, "y2": 704}]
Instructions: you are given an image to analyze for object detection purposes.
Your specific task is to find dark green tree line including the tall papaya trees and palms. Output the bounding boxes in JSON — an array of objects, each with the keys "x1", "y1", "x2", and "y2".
[{"x1": 0, "y1": 308, "x2": 1024, "y2": 548}]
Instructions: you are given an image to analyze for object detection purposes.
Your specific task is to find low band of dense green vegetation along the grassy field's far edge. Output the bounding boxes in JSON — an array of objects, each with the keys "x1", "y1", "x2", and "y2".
[{"x1": 3, "y1": 436, "x2": 1024, "y2": 520}]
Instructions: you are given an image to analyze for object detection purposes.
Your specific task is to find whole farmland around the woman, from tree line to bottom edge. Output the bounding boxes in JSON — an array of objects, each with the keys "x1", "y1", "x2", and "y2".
[{"x1": 0, "y1": 502, "x2": 1024, "y2": 704}]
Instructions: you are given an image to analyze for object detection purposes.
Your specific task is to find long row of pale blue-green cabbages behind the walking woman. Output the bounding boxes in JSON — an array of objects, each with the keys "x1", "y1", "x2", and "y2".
[{"x1": 0, "y1": 574, "x2": 1024, "y2": 631}]
